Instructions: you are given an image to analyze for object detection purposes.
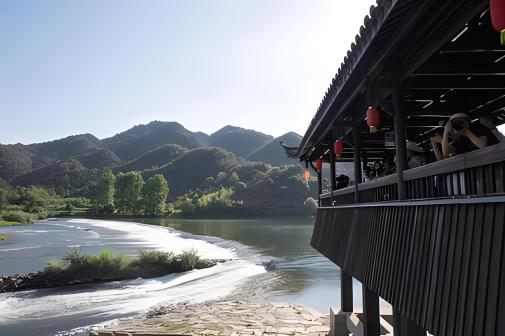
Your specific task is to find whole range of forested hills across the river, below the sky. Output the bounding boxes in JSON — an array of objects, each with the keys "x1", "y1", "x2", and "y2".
[{"x1": 0, "y1": 121, "x2": 316, "y2": 215}]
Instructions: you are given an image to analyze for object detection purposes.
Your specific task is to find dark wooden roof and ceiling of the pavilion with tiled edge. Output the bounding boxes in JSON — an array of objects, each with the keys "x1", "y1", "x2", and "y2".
[{"x1": 291, "y1": 0, "x2": 505, "y2": 160}]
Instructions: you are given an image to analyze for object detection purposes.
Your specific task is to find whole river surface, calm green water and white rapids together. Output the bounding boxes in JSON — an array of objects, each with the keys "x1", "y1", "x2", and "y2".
[{"x1": 0, "y1": 217, "x2": 359, "y2": 336}]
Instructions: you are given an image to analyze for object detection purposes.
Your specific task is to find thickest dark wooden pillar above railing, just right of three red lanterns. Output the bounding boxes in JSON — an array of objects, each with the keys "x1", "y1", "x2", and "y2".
[{"x1": 392, "y1": 87, "x2": 408, "y2": 200}]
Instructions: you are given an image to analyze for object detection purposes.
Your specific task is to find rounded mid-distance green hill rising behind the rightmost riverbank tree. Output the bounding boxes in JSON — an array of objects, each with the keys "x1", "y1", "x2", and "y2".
[{"x1": 144, "y1": 147, "x2": 245, "y2": 198}]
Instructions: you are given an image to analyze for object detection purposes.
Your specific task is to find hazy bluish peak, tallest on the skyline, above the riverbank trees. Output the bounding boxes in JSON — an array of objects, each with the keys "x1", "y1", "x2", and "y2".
[{"x1": 102, "y1": 121, "x2": 204, "y2": 161}]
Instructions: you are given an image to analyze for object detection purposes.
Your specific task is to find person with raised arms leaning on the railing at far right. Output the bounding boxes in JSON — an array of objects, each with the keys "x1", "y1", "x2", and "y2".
[{"x1": 431, "y1": 113, "x2": 503, "y2": 160}]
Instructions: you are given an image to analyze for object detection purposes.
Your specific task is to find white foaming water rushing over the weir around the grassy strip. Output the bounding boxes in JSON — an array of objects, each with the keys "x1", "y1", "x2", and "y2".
[{"x1": 0, "y1": 219, "x2": 265, "y2": 335}]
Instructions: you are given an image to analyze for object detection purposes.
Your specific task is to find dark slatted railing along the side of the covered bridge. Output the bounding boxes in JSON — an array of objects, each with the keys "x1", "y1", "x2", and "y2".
[{"x1": 320, "y1": 143, "x2": 505, "y2": 206}]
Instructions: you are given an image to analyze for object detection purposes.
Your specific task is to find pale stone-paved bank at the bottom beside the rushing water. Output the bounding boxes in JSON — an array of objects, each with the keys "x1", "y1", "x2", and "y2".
[{"x1": 90, "y1": 300, "x2": 330, "y2": 336}]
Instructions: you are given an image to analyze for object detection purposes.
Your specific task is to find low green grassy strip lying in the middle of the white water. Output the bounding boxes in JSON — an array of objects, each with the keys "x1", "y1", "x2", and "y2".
[{"x1": 0, "y1": 249, "x2": 218, "y2": 291}]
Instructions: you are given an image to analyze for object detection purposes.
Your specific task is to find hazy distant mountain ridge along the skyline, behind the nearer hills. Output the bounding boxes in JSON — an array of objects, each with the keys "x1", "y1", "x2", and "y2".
[{"x1": 0, "y1": 120, "x2": 301, "y2": 183}]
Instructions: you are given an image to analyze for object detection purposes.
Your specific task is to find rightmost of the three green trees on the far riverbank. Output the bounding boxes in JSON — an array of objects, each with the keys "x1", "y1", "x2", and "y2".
[{"x1": 142, "y1": 174, "x2": 168, "y2": 216}]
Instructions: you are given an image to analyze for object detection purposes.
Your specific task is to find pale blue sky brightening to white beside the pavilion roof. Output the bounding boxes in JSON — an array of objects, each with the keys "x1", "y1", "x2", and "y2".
[{"x1": 0, "y1": 0, "x2": 373, "y2": 144}]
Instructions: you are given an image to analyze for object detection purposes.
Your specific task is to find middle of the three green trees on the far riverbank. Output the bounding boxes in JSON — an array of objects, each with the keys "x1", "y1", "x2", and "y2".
[{"x1": 114, "y1": 171, "x2": 144, "y2": 214}]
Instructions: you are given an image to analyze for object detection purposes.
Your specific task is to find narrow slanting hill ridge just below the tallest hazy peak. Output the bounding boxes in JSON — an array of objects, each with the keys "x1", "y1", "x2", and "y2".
[{"x1": 113, "y1": 145, "x2": 187, "y2": 172}]
